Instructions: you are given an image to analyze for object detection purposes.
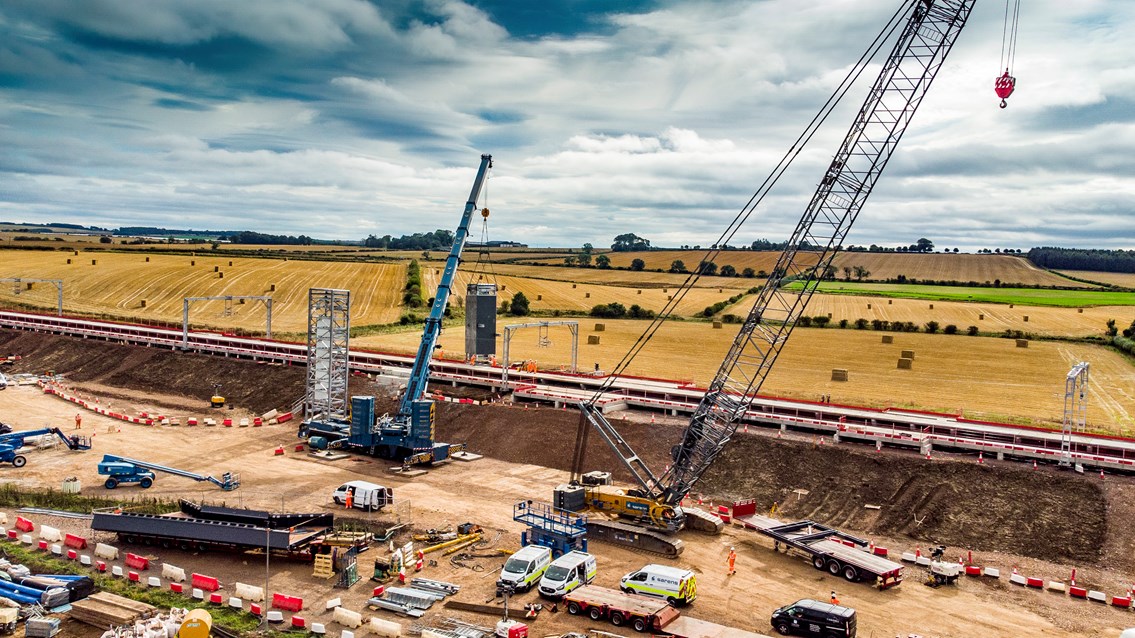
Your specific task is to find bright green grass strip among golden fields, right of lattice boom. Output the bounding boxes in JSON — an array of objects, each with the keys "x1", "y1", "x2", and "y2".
[{"x1": 799, "y1": 282, "x2": 1135, "y2": 308}]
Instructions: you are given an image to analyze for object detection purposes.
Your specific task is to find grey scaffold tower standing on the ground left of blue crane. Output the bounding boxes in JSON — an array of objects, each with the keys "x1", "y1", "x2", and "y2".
[{"x1": 303, "y1": 288, "x2": 351, "y2": 420}]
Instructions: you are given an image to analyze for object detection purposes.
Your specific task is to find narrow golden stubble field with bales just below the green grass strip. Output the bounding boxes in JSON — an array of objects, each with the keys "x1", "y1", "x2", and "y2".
[{"x1": 724, "y1": 294, "x2": 1135, "y2": 337}]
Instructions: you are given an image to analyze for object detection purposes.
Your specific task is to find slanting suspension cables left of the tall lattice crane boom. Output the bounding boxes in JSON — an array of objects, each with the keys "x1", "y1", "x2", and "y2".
[{"x1": 587, "y1": 2, "x2": 909, "y2": 403}]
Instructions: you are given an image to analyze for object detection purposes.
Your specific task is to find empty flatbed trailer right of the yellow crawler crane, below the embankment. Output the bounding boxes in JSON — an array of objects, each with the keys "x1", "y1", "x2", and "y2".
[{"x1": 733, "y1": 501, "x2": 902, "y2": 589}]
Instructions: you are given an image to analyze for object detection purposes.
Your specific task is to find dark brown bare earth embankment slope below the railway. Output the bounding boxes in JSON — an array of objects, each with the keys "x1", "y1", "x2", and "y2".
[{"x1": 0, "y1": 330, "x2": 1116, "y2": 569}]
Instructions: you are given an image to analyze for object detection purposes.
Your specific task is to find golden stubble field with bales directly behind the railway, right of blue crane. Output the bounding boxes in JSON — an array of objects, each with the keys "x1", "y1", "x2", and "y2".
[{"x1": 365, "y1": 319, "x2": 1135, "y2": 436}]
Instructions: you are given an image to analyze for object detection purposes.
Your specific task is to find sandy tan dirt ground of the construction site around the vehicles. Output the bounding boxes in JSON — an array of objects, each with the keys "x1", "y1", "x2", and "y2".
[{"x1": 0, "y1": 387, "x2": 1135, "y2": 638}]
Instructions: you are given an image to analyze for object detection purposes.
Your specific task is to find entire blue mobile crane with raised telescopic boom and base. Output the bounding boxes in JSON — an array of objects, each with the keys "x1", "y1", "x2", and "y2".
[{"x1": 299, "y1": 154, "x2": 493, "y2": 467}]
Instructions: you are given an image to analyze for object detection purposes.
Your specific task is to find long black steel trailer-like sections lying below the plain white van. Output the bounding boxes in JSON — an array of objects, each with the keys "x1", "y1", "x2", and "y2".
[{"x1": 91, "y1": 510, "x2": 331, "y2": 556}]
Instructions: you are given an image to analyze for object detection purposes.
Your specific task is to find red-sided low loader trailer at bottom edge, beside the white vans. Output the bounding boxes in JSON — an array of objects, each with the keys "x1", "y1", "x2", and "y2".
[{"x1": 562, "y1": 585, "x2": 767, "y2": 638}]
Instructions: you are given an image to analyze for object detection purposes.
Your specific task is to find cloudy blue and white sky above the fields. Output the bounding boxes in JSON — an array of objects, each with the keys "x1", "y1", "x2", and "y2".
[{"x1": 0, "y1": 0, "x2": 1135, "y2": 251}]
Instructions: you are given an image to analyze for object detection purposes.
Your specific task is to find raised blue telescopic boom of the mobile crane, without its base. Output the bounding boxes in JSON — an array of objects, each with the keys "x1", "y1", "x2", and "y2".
[{"x1": 398, "y1": 153, "x2": 493, "y2": 420}]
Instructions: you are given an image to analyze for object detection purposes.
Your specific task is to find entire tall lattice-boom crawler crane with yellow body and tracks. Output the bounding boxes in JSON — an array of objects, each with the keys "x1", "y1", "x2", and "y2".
[{"x1": 555, "y1": 0, "x2": 976, "y2": 555}]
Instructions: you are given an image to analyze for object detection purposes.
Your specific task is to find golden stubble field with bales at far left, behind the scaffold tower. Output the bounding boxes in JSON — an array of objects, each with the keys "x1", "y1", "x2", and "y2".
[{"x1": 0, "y1": 251, "x2": 405, "y2": 333}]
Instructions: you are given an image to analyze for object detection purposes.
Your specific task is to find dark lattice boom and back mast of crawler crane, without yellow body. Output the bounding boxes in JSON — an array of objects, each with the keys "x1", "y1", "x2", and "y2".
[{"x1": 573, "y1": 0, "x2": 975, "y2": 518}]
